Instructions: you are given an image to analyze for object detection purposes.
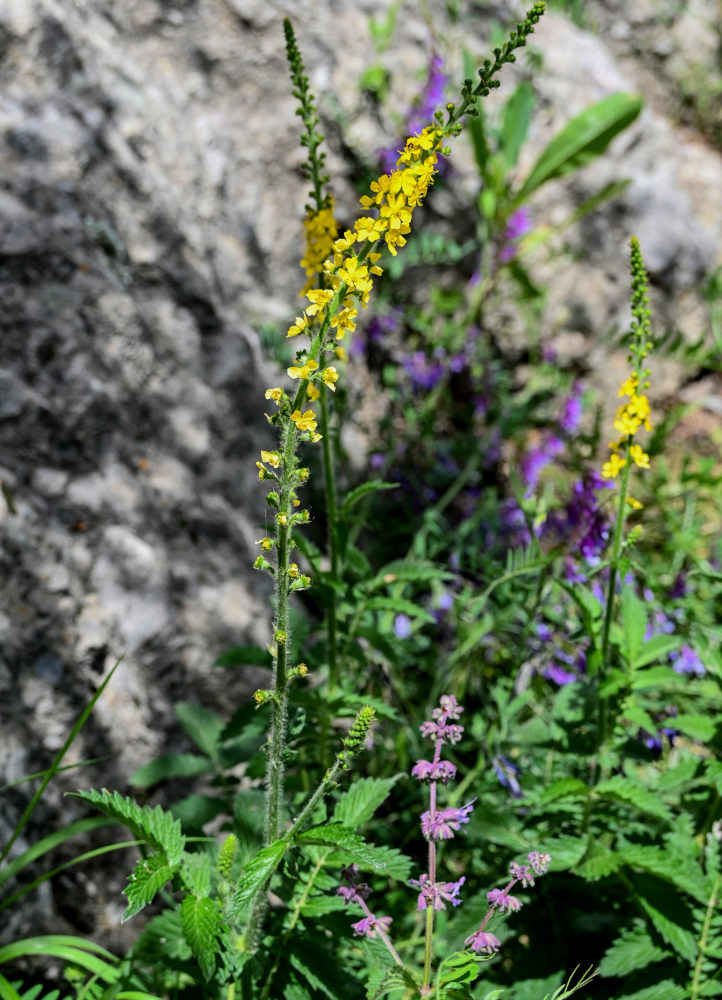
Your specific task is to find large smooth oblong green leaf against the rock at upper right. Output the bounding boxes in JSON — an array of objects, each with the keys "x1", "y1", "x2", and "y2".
[{"x1": 514, "y1": 93, "x2": 642, "y2": 204}]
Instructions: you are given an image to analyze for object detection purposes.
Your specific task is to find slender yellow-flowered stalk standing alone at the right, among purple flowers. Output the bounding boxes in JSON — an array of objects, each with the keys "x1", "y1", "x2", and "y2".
[{"x1": 598, "y1": 238, "x2": 652, "y2": 745}]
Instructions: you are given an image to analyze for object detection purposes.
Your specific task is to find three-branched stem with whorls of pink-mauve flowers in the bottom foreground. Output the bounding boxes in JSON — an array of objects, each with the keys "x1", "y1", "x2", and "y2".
[{"x1": 337, "y1": 695, "x2": 551, "y2": 996}]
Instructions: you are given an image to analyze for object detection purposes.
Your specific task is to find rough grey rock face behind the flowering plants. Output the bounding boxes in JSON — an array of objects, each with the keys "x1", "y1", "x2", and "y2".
[{"x1": 0, "y1": 0, "x2": 722, "y2": 948}]
